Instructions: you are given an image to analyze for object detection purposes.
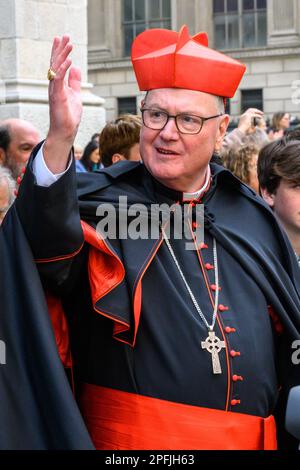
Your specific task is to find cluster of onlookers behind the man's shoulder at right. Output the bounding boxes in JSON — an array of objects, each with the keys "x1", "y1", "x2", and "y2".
[{"x1": 216, "y1": 108, "x2": 300, "y2": 265}]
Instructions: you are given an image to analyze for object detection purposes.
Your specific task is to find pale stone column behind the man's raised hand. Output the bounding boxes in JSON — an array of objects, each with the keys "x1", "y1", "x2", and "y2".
[{"x1": 0, "y1": 0, "x2": 105, "y2": 145}]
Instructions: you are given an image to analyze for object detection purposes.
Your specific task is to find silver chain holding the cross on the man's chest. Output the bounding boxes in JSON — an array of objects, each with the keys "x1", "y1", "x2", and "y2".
[{"x1": 161, "y1": 227, "x2": 219, "y2": 331}]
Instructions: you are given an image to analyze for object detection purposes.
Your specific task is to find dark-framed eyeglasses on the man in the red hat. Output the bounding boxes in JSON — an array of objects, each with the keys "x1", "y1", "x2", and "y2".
[{"x1": 141, "y1": 108, "x2": 223, "y2": 134}]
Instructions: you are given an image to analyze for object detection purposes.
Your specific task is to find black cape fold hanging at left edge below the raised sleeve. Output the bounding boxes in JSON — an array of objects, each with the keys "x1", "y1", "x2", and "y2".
[{"x1": 0, "y1": 206, "x2": 93, "y2": 450}]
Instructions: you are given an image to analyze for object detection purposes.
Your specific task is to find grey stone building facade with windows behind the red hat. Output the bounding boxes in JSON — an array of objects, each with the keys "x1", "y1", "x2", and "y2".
[{"x1": 88, "y1": 0, "x2": 300, "y2": 123}]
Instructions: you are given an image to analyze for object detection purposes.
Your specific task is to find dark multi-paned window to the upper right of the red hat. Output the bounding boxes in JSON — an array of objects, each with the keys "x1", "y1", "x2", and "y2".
[{"x1": 213, "y1": 0, "x2": 267, "y2": 49}]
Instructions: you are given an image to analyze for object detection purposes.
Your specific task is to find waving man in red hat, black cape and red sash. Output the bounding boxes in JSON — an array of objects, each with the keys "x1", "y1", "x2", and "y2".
[{"x1": 0, "y1": 26, "x2": 300, "y2": 452}]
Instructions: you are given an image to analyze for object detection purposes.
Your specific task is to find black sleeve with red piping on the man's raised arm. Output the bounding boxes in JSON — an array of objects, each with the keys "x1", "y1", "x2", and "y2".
[{"x1": 16, "y1": 144, "x2": 83, "y2": 285}]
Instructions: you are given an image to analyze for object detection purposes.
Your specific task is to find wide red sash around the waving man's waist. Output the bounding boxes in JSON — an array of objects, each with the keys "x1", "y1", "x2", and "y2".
[{"x1": 81, "y1": 384, "x2": 277, "y2": 450}]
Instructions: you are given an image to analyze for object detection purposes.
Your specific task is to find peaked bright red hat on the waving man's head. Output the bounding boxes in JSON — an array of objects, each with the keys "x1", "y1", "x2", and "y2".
[{"x1": 131, "y1": 25, "x2": 246, "y2": 98}]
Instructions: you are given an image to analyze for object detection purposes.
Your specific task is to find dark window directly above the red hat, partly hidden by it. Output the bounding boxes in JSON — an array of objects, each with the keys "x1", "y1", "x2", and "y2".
[{"x1": 123, "y1": 0, "x2": 171, "y2": 57}]
